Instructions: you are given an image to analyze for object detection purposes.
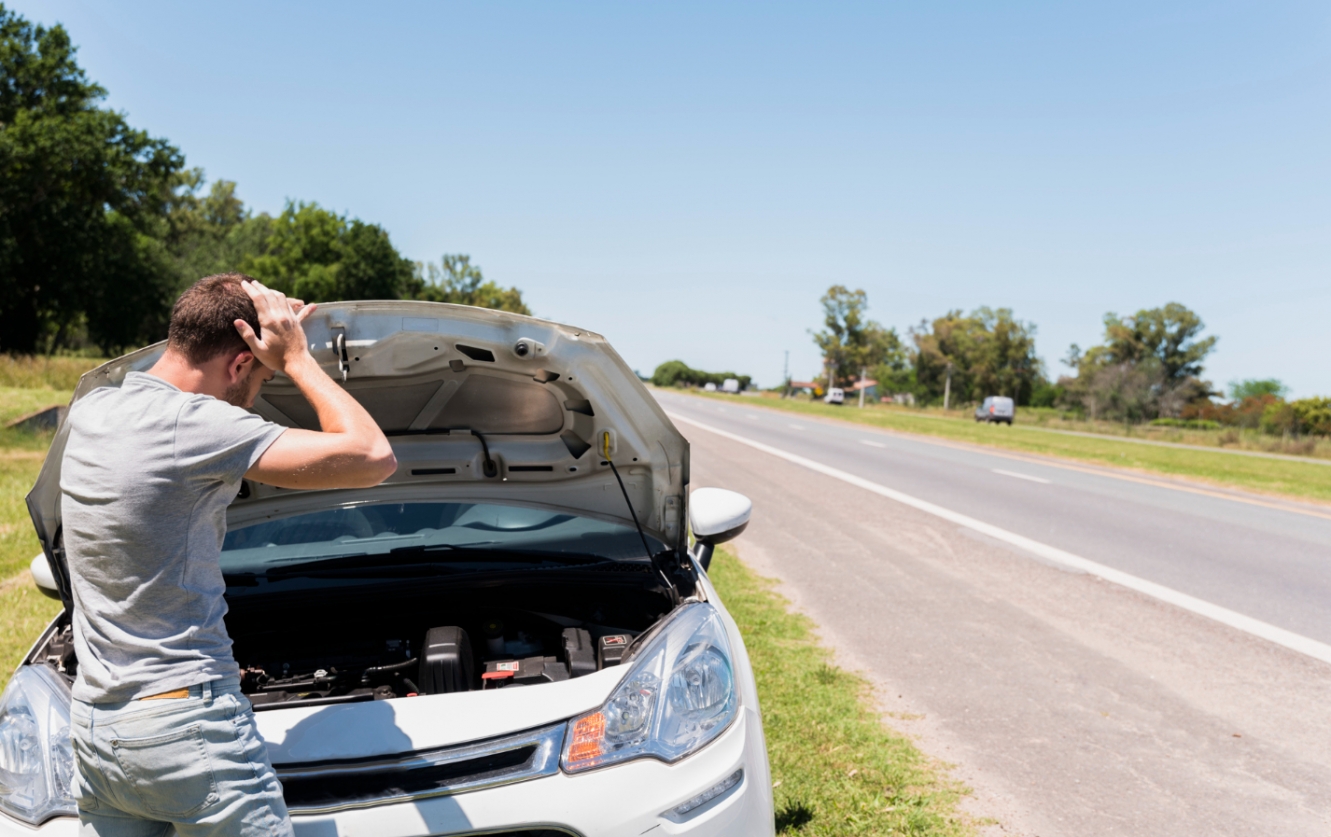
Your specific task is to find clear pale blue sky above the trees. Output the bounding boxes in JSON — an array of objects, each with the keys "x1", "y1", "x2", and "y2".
[{"x1": 12, "y1": 0, "x2": 1331, "y2": 397}]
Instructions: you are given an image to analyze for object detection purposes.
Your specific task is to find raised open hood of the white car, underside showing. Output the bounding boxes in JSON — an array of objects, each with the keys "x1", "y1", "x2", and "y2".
[{"x1": 28, "y1": 301, "x2": 688, "y2": 574}]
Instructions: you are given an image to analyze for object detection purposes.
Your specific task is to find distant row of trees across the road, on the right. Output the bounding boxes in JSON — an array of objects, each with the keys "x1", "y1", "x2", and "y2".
[{"x1": 813, "y1": 285, "x2": 1331, "y2": 435}]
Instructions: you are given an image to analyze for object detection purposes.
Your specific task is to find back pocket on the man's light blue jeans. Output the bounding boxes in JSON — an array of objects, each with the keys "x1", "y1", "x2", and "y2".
[{"x1": 110, "y1": 724, "x2": 218, "y2": 817}]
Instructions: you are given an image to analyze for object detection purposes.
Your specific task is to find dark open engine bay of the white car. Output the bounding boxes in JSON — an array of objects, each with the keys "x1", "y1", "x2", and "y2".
[{"x1": 226, "y1": 572, "x2": 673, "y2": 711}]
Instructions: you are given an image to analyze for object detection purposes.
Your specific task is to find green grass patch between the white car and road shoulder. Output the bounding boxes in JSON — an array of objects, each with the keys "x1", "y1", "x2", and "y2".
[{"x1": 708, "y1": 551, "x2": 974, "y2": 837}]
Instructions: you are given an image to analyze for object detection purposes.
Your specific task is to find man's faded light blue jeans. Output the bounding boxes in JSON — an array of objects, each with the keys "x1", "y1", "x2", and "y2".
[{"x1": 71, "y1": 677, "x2": 291, "y2": 837}]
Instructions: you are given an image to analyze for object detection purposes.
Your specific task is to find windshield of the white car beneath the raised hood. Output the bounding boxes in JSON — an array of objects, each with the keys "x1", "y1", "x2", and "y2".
[{"x1": 221, "y1": 503, "x2": 663, "y2": 574}]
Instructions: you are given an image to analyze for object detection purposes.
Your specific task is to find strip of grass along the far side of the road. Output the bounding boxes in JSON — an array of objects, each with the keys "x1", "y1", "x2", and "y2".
[{"x1": 699, "y1": 394, "x2": 1331, "y2": 502}]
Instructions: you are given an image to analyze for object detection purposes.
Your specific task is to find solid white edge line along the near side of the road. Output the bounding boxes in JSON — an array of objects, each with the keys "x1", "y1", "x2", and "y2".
[{"x1": 668, "y1": 413, "x2": 1331, "y2": 663}]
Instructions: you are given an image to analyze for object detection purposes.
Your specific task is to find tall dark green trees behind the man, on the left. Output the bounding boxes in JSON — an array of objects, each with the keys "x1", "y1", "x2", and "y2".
[{"x1": 0, "y1": 4, "x2": 531, "y2": 354}]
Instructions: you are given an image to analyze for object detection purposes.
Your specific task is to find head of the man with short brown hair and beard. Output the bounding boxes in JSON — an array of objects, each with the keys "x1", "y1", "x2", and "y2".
[{"x1": 166, "y1": 273, "x2": 273, "y2": 407}]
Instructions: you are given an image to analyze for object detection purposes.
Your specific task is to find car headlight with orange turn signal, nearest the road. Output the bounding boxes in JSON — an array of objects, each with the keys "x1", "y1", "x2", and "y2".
[{"x1": 563, "y1": 604, "x2": 739, "y2": 773}]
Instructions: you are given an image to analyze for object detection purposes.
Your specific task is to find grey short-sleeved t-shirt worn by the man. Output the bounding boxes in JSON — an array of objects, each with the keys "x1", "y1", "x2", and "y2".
[{"x1": 60, "y1": 373, "x2": 286, "y2": 703}]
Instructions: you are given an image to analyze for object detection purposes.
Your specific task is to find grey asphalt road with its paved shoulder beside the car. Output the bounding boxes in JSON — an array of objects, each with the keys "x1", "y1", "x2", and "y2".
[{"x1": 658, "y1": 393, "x2": 1331, "y2": 837}]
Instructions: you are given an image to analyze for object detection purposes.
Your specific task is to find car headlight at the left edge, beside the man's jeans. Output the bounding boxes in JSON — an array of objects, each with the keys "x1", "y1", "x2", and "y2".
[{"x1": 0, "y1": 665, "x2": 79, "y2": 825}]
